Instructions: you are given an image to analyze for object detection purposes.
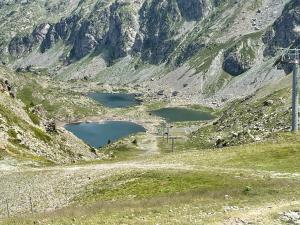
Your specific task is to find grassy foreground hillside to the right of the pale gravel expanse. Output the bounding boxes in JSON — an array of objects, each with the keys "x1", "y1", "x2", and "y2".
[{"x1": 2, "y1": 133, "x2": 300, "y2": 225}]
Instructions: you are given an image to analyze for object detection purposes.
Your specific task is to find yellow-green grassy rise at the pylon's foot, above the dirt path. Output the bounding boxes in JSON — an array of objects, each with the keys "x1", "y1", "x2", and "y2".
[{"x1": 224, "y1": 133, "x2": 300, "y2": 172}]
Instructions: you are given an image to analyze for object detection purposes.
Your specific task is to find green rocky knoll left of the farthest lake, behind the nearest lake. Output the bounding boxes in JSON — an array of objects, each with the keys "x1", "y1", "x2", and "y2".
[{"x1": 16, "y1": 73, "x2": 103, "y2": 120}]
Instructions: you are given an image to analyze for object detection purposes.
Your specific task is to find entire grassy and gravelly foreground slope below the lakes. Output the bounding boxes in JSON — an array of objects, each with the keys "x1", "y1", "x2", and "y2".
[{"x1": 0, "y1": 133, "x2": 300, "y2": 225}]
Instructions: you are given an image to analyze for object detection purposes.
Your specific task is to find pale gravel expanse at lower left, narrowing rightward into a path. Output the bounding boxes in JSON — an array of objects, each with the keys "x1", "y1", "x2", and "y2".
[{"x1": 0, "y1": 161, "x2": 191, "y2": 217}]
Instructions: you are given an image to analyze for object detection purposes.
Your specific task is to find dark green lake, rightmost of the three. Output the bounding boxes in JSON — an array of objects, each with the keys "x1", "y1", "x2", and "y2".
[{"x1": 151, "y1": 108, "x2": 214, "y2": 123}]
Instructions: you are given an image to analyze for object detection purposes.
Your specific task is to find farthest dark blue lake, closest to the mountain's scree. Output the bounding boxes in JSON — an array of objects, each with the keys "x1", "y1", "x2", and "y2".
[{"x1": 88, "y1": 92, "x2": 141, "y2": 108}]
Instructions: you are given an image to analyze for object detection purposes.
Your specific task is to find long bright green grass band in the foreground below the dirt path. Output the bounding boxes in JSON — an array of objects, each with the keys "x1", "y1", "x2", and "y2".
[{"x1": 76, "y1": 170, "x2": 299, "y2": 203}]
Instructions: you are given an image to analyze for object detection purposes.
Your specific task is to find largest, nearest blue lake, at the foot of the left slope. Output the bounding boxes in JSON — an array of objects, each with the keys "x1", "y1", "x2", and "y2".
[{"x1": 65, "y1": 121, "x2": 146, "y2": 148}]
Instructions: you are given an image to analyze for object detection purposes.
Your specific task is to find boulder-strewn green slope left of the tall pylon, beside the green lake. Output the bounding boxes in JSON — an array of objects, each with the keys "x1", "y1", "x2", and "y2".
[{"x1": 192, "y1": 89, "x2": 291, "y2": 148}]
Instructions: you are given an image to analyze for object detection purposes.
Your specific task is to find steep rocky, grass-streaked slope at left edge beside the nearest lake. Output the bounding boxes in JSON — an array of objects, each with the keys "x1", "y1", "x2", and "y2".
[{"x1": 0, "y1": 67, "x2": 98, "y2": 164}]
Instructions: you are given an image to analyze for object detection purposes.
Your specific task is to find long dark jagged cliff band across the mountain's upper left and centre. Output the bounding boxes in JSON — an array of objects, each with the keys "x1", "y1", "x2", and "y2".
[{"x1": 2, "y1": 0, "x2": 212, "y2": 64}]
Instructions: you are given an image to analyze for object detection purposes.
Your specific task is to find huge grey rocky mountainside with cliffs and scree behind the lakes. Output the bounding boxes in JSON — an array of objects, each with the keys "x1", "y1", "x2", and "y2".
[{"x1": 0, "y1": 0, "x2": 299, "y2": 104}]
